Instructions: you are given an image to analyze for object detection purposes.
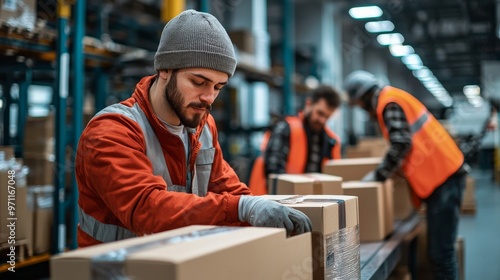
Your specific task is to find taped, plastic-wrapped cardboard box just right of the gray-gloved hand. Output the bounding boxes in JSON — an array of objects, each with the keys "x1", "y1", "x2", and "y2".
[{"x1": 262, "y1": 195, "x2": 360, "y2": 280}]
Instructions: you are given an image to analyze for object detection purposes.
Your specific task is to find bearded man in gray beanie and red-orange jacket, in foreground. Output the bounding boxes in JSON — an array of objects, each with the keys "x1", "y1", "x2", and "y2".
[{"x1": 75, "y1": 10, "x2": 311, "y2": 247}]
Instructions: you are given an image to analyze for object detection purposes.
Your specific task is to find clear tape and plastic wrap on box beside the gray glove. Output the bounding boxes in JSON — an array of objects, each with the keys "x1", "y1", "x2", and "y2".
[{"x1": 278, "y1": 195, "x2": 361, "y2": 280}]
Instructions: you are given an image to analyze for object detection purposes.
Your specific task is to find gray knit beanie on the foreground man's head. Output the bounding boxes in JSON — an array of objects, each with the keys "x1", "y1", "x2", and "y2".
[{"x1": 155, "y1": 10, "x2": 236, "y2": 76}]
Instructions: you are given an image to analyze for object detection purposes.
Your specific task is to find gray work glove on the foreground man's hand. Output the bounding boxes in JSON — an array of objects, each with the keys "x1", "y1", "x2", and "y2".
[{"x1": 238, "y1": 195, "x2": 312, "y2": 235}]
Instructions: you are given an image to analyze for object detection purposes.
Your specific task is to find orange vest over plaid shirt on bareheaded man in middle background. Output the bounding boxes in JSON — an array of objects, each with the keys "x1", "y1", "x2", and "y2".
[{"x1": 248, "y1": 116, "x2": 340, "y2": 195}]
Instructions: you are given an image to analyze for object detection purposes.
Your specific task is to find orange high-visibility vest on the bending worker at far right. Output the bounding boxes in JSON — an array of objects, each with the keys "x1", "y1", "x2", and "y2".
[{"x1": 377, "y1": 86, "x2": 464, "y2": 205}]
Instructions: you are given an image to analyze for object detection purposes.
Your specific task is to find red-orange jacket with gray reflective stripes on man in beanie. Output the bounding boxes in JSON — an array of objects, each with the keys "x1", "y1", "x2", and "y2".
[{"x1": 75, "y1": 76, "x2": 251, "y2": 247}]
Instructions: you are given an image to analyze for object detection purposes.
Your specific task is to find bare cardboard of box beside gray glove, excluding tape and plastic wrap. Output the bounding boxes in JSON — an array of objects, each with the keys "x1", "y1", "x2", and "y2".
[{"x1": 263, "y1": 195, "x2": 359, "y2": 280}]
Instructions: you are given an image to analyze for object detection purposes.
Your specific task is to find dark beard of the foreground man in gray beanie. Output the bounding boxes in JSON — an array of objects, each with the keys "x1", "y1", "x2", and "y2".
[{"x1": 165, "y1": 71, "x2": 211, "y2": 128}]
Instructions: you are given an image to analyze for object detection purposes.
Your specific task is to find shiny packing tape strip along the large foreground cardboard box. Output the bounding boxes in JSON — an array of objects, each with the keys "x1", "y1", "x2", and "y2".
[{"x1": 91, "y1": 227, "x2": 241, "y2": 280}]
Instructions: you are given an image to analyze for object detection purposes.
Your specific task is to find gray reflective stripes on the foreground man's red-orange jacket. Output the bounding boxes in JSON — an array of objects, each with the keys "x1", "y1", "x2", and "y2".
[{"x1": 79, "y1": 103, "x2": 215, "y2": 242}]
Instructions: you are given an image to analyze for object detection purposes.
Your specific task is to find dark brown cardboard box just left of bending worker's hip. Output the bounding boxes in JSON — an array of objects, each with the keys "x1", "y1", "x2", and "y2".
[{"x1": 392, "y1": 175, "x2": 415, "y2": 220}]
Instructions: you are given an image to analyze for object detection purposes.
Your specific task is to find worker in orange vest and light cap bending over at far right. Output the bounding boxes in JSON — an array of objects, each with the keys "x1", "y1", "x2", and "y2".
[{"x1": 344, "y1": 71, "x2": 467, "y2": 280}]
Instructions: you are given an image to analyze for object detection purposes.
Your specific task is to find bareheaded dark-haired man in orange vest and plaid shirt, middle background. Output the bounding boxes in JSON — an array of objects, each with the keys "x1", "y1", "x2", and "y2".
[{"x1": 248, "y1": 86, "x2": 341, "y2": 195}]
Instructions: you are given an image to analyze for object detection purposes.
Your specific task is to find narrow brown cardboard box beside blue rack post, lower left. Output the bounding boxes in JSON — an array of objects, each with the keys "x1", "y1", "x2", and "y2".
[{"x1": 28, "y1": 186, "x2": 54, "y2": 254}]
